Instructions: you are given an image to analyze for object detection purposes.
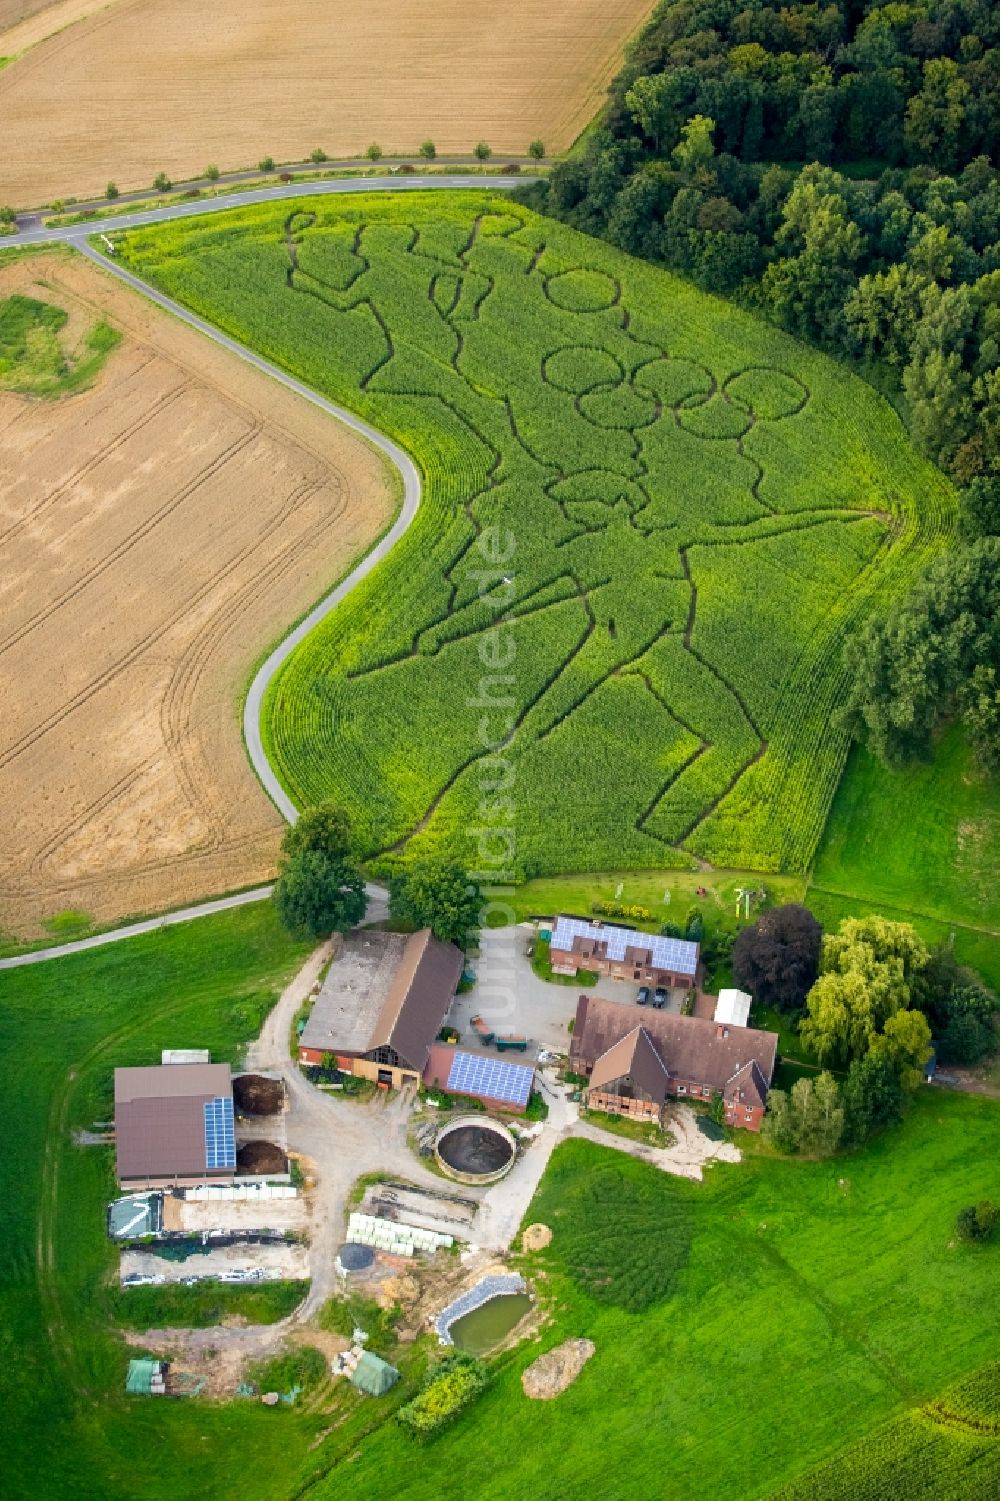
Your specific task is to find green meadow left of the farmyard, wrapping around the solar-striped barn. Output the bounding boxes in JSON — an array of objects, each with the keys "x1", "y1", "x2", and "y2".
[{"x1": 0, "y1": 904, "x2": 314, "y2": 1501}]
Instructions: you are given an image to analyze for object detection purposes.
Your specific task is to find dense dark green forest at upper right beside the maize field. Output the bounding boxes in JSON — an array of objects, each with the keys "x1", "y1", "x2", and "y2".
[{"x1": 516, "y1": 0, "x2": 1000, "y2": 764}]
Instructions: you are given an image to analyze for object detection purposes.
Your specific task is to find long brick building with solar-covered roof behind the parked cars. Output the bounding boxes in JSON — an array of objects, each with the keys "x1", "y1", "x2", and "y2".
[{"x1": 550, "y1": 917, "x2": 698, "y2": 991}]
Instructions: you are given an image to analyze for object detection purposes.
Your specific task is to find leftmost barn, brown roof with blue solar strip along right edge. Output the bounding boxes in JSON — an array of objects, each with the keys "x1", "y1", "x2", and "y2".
[{"x1": 114, "y1": 1063, "x2": 236, "y2": 1189}]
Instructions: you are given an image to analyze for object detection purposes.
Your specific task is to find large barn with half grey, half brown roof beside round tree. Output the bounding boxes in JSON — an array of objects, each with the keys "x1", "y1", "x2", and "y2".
[{"x1": 299, "y1": 928, "x2": 462, "y2": 1090}]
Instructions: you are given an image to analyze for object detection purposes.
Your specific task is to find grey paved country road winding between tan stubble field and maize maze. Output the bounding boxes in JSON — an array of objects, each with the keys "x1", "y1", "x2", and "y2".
[{"x1": 0, "y1": 176, "x2": 536, "y2": 970}]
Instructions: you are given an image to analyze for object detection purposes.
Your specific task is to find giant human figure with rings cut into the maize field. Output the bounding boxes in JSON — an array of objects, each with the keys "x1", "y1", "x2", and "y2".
[{"x1": 288, "y1": 215, "x2": 870, "y2": 844}]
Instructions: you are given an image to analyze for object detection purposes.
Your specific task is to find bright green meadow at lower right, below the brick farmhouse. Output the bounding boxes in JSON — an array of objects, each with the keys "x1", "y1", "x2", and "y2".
[{"x1": 301, "y1": 1094, "x2": 1000, "y2": 1501}]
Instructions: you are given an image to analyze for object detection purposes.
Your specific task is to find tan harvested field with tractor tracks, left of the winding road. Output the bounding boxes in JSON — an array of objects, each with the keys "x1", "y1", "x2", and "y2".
[{"x1": 0, "y1": 252, "x2": 395, "y2": 938}]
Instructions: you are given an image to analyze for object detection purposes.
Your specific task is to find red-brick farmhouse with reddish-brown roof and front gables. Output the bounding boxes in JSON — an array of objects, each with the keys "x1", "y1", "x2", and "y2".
[{"x1": 569, "y1": 995, "x2": 778, "y2": 1130}]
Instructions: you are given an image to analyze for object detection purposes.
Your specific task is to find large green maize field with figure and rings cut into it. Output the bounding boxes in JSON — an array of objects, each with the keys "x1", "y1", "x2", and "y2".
[{"x1": 122, "y1": 192, "x2": 953, "y2": 875}]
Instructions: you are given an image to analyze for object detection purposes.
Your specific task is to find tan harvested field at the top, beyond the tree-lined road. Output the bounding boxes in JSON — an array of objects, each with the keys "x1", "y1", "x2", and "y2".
[{"x1": 0, "y1": 0, "x2": 653, "y2": 207}]
